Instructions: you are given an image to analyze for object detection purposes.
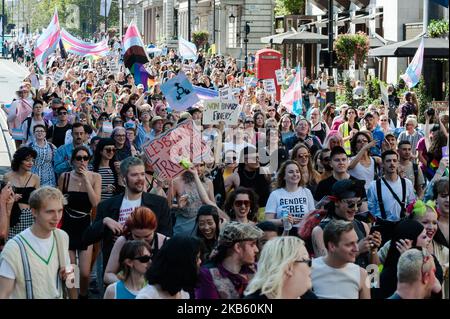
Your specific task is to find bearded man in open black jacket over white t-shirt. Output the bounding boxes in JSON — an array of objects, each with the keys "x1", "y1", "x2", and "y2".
[{"x1": 84, "y1": 157, "x2": 172, "y2": 269}]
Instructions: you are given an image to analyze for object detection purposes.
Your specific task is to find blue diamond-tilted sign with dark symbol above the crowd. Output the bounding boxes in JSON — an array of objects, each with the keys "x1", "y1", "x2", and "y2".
[{"x1": 161, "y1": 72, "x2": 199, "y2": 111}]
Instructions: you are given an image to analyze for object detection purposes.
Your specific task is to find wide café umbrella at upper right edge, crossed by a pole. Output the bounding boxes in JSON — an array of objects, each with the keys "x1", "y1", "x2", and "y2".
[{"x1": 369, "y1": 37, "x2": 448, "y2": 58}]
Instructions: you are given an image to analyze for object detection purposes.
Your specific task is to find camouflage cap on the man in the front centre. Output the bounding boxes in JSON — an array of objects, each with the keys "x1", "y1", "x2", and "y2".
[{"x1": 218, "y1": 222, "x2": 264, "y2": 247}]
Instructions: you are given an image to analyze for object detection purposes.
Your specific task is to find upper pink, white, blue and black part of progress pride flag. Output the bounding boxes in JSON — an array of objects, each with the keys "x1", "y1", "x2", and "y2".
[{"x1": 122, "y1": 22, "x2": 150, "y2": 70}]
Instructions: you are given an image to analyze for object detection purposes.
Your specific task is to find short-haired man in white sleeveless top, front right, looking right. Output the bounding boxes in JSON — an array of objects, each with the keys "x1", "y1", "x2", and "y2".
[{"x1": 311, "y1": 220, "x2": 370, "y2": 299}]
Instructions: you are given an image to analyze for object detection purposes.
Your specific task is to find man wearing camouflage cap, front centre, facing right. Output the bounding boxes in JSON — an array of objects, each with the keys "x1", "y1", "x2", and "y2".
[{"x1": 195, "y1": 222, "x2": 264, "y2": 299}]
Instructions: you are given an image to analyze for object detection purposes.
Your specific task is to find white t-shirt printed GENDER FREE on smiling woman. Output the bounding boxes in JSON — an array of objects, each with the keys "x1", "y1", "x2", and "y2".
[{"x1": 266, "y1": 187, "x2": 315, "y2": 227}]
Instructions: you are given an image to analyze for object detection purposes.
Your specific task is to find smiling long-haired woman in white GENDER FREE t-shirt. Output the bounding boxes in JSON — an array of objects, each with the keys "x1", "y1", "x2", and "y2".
[{"x1": 266, "y1": 160, "x2": 314, "y2": 235}]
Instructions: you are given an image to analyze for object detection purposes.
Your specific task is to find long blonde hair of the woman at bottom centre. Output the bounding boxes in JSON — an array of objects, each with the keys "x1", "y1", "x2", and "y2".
[{"x1": 244, "y1": 236, "x2": 306, "y2": 299}]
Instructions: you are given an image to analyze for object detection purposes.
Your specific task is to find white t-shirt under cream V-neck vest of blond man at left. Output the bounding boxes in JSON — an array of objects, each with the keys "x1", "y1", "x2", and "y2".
[{"x1": 0, "y1": 228, "x2": 70, "y2": 279}]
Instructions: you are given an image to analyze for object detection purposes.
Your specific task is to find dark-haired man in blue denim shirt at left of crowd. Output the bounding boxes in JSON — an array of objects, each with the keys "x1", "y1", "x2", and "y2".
[{"x1": 54, "y1": 123, "x2": 92, "y2": 176}]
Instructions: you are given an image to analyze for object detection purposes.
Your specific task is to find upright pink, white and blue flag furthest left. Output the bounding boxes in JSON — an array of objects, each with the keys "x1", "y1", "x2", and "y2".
[{"x1": 34, "y1": 8, "x2": 60, "y2": 72}]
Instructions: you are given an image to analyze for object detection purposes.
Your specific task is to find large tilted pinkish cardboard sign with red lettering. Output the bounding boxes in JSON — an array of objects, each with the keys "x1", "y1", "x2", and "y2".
[{"x1": 143, "y1": 120, "x2": 211, "y2": 179}]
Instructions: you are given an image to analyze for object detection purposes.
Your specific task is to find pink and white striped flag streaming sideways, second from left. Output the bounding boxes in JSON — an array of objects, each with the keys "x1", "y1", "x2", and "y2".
[{"x1": 61, "y1": 29, "x2": 110, "y2": 60}]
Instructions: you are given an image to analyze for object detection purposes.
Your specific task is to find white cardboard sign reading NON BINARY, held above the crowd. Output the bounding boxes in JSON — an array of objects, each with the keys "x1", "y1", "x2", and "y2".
[{"x1": 203, "y1": 99, "x2": 242, "y2": 125}]
